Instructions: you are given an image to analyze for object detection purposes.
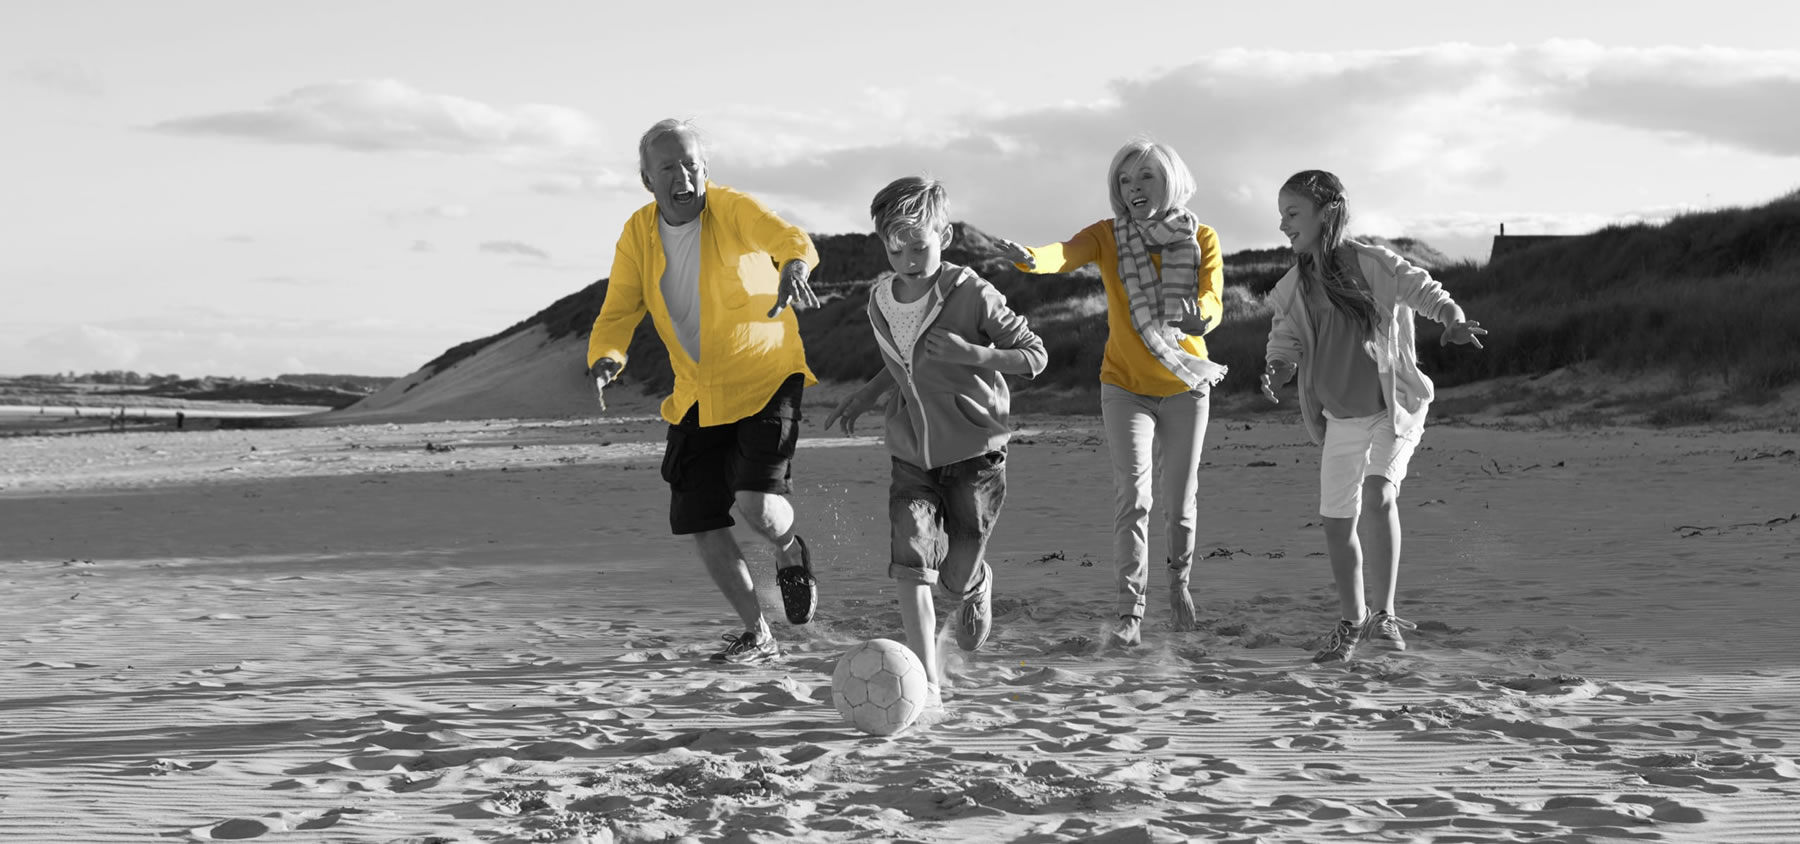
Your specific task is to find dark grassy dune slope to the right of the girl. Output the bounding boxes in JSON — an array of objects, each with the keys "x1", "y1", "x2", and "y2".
[{"x1": 1420, "y1": 191, "x2": 1800, "y2": 403}]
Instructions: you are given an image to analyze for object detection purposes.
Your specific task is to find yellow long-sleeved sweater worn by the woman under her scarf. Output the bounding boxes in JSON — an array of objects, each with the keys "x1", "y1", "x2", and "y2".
[{"x1": 1019, "y1": 220, "x2": 1226, "y2": 398}]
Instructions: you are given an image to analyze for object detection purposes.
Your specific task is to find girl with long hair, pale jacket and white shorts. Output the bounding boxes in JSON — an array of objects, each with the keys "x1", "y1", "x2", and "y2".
[{"x1": 1262, "y1": 169, "x2": 1487, "y2": 662}]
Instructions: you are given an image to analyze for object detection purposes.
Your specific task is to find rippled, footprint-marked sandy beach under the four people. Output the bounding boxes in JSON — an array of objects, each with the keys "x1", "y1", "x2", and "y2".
[{"x1": 0, "y1": 412, "x2": 1800, "y2": 842}]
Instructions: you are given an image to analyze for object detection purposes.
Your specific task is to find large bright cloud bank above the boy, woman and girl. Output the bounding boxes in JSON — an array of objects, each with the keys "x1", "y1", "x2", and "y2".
[{"x1": 713, "y1": 41, "x2": 1800, "y2": 256}]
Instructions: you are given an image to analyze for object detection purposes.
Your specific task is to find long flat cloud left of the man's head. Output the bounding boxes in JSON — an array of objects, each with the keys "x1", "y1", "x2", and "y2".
[{"x1": 151, "y1": 79, "x2": 599, "y2": 158}]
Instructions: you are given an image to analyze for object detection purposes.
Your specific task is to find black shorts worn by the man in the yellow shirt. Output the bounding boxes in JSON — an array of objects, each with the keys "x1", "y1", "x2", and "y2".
[{"x1": 662, "y1": 373, "x2": 806, "y2": 536}]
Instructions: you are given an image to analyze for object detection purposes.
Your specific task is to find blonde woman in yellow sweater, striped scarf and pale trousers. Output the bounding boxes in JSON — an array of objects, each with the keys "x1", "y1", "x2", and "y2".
[{"x1": 1001, "y1": 139, "x2": 1226, "y2": 646}]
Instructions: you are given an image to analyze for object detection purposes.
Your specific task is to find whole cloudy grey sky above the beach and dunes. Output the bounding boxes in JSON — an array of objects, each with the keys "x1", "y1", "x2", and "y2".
[{"x1": 0, "y1": 0, "x2": 1800, "y2": 378}]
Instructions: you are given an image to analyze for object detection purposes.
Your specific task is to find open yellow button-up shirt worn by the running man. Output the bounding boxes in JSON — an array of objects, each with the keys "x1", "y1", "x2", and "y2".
[{"x1": 587, "y1": 182, "x2": 819, "y2": 425}]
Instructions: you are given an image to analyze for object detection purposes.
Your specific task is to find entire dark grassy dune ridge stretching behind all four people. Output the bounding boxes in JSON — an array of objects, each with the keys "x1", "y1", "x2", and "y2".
[{"x1": 376, "y1": 193, "x2": 1800, "y2": 424}]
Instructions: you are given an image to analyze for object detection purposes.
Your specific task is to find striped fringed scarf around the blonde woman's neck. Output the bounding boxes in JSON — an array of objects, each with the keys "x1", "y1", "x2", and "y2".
[{"x1": 1112, "y1": 209, "x2": 1226, "y2": 391}]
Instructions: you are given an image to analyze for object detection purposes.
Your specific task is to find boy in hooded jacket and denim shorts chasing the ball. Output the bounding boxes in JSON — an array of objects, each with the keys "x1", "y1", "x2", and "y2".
[{"x1": 824, "y1": 176, "x2": 1049, "y2": 702}]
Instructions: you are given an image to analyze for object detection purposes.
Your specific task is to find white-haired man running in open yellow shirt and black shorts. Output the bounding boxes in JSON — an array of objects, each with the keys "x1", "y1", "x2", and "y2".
[{"x1": 587, "y1": 121, "x2": 819, "y2": 662}]
